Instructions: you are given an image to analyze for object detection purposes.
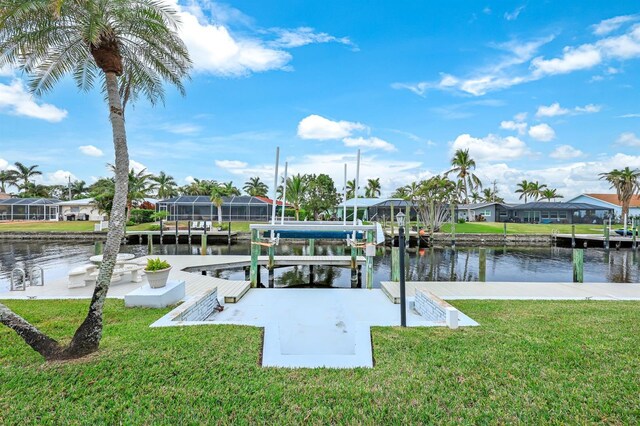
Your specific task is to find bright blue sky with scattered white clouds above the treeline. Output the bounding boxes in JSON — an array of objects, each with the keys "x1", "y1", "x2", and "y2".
[{"x1": 0, "y1": 0, "x2": 640, "y2": 200}]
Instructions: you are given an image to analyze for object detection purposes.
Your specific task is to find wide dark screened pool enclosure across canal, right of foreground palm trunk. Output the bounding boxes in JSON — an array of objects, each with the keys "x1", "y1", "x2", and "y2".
[{"x1": 157, "y1": 195, "x2": 282, "y2": 222}]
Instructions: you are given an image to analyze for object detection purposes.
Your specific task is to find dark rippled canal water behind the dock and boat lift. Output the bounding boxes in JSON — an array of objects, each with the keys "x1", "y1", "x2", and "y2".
[{"x1": 0, "y1": 241, "x2": 640, "y2": 292}]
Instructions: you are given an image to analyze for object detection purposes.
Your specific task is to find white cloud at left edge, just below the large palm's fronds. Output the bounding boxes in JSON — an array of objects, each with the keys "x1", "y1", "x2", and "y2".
[{"x1": 0, "y1": 80, "x2": 67, "y2": 123}]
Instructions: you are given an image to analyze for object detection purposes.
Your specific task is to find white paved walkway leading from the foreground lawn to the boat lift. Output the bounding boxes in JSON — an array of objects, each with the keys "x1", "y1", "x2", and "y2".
[{"x1": 152, "y1": 289, "x2": 478, "y2": 368}]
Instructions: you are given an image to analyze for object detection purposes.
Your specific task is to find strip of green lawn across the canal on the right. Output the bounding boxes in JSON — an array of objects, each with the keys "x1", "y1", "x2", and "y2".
[{"x1": 442, "y1": 222, "x2": 622, "y2": 235}]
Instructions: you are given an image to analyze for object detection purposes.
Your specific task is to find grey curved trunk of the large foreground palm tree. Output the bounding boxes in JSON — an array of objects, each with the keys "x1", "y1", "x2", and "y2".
[{"x1": 64, "y1": 72, "x2": 129, "y2": 358}]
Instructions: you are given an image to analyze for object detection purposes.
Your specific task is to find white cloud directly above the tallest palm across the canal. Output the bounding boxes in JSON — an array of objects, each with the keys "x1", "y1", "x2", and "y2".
[{"x1": 451, "y1": 134, "x2": 530, "y2": 162}]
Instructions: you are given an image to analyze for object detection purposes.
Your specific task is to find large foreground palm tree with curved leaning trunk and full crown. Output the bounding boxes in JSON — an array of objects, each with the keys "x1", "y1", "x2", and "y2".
[{"x1": 0, "y1": 0, "x2": 191, "y2": 359}]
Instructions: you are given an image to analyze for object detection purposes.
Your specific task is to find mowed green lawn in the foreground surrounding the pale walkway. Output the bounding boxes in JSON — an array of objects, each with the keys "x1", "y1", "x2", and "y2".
[{"x1": 0, "y1": 300, "x2": 640, "y2": 424}]
